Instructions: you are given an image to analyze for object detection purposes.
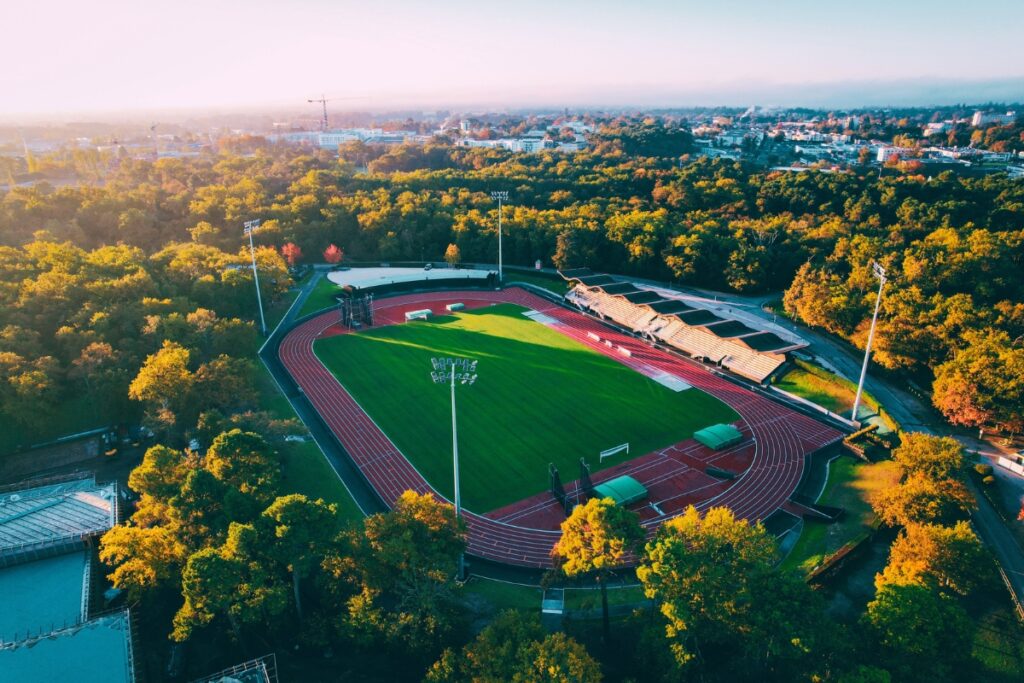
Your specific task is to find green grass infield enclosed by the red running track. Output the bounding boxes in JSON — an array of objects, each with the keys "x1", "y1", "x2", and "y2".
[{"x1": 314, "y1": 304, "x2": 738, "y2": 513}]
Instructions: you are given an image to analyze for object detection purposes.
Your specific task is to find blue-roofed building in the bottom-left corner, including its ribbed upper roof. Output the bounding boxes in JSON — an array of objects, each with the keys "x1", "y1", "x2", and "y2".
[{"x1": 0, "y1": 475, "x2": 135, "y2": 683}]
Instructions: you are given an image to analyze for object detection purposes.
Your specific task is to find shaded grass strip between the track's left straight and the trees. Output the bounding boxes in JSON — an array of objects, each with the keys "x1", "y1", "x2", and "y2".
[{"x1": 258, "y1": 366, "x2": 362, "y2": 521}]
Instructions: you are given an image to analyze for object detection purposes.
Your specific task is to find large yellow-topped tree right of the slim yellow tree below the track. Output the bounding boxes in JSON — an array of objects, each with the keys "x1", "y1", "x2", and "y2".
[{"x1": 637, "y1": 506, "x2": 776, "y2": 667}]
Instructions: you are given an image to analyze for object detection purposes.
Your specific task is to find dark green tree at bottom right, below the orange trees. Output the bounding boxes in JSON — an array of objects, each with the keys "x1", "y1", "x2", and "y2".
[{"x1": 864, "y1": 584, "x2": 974, "y2": 682}]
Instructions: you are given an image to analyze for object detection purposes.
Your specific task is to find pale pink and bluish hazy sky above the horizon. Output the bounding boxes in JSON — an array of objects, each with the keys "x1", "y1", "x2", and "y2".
[{"x1": 0, "y1": 0, "x2": 1024, "y2": 116}]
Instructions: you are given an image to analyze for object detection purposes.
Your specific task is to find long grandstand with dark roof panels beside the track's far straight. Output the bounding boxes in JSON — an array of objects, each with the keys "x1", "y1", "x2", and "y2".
[{"x1": 559, "y1": 268, "x2": 806, "y2": 382}]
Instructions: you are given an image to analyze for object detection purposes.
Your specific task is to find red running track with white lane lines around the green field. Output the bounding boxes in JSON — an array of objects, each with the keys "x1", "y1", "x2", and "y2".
[{"x1": 279, "y1": 288, "x2": 842, "y2": 567}]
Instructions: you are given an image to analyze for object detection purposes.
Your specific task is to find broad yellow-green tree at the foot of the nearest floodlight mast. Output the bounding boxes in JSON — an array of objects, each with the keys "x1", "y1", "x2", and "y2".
[{"x1": 325, "y1": 490, "x2": 466, "y2": 652}]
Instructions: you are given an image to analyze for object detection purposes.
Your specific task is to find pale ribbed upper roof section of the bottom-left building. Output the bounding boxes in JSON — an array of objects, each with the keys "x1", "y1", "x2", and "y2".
[{"x1": 0, "y1": 478, "x2": 117, "y2": 560}]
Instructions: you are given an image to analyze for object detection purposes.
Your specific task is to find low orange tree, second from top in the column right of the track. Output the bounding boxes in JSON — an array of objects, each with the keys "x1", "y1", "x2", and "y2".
[{"x1": 871, "y1": 472, "x2": 975, "y2": 526}]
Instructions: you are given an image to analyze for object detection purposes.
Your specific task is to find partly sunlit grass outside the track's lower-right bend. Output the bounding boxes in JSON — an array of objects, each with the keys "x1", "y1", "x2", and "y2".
[{"x1": 782, "y1": 456, "x2": 900, "y2": 573}]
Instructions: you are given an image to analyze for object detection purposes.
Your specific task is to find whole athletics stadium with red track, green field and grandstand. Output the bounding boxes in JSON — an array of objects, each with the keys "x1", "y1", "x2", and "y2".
[{"x1": 274, "y1": 268, "x2": 843, "y2": 569}]
